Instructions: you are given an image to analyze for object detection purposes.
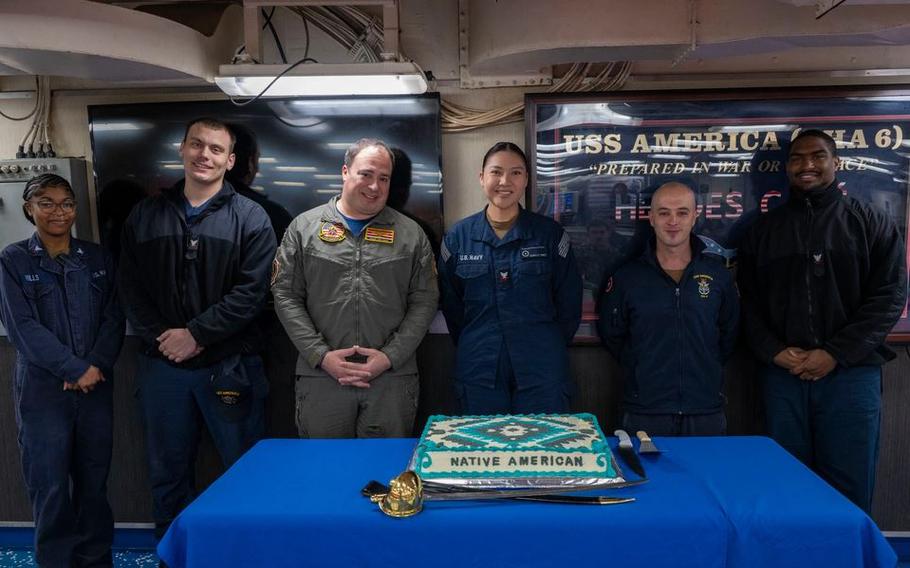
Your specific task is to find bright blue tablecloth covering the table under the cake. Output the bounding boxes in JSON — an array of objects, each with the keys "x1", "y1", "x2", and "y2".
[{"x1": 158, "y1": 437, "x2": 897, "y2": 568}]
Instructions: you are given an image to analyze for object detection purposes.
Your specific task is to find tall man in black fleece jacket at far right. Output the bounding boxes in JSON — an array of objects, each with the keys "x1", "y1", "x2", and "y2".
[{"x1": 739, "y1": 130, "x2": 907, "y2": 512}]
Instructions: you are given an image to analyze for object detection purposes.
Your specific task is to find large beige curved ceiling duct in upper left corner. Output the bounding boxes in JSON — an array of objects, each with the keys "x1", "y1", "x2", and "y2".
[{"x1": 0, "y1": 0, "x2": 242, "y2": 85}]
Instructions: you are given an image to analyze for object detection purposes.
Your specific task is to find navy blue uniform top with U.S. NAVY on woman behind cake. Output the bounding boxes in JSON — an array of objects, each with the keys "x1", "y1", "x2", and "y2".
[{"x1": 439, "y1": 209, "x2": 582, "y2": 414}]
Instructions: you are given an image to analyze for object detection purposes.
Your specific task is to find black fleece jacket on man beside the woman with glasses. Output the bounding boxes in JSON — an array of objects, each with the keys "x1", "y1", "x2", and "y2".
[{"x1": 118, "y1": 181, "x2": 276, "y2": 368}]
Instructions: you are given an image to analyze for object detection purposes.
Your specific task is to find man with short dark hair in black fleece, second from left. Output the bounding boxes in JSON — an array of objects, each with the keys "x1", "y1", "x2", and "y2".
[{"x1": 119, "y1": 119, "x2": 275, "y2": 538}]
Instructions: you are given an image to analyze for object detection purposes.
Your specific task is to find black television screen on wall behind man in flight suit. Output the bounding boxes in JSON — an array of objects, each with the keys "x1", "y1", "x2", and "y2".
[{"x1": 88, "y1": 95, "x2": 443, "y2": 247}]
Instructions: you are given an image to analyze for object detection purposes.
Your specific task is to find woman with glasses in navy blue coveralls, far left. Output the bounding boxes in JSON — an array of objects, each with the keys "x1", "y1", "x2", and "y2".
[{"x1": 0, "y1": 174, "x2": 124, "y2": 568}]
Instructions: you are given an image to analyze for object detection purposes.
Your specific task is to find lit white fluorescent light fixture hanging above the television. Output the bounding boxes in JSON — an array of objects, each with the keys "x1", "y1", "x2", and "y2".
[{"x1": 215, "y1": 62, "x2": 427, "y2": 97}]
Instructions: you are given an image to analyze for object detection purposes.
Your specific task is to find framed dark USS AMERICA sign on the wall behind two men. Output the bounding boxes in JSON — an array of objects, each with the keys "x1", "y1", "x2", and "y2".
[{"x1": 525, "y1": 89, "x2": 910, "y2": 341}]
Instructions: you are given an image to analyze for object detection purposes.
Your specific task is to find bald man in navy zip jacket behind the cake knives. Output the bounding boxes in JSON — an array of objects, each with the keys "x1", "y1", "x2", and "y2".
[{"x1": 597, "y1": 182, "x2": 739, "y2": 436}]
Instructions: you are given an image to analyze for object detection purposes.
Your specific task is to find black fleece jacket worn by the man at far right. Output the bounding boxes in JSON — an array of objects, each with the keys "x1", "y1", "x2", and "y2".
[{"x1": 738, "y1": 180, "x2": 907, "y2": 367}]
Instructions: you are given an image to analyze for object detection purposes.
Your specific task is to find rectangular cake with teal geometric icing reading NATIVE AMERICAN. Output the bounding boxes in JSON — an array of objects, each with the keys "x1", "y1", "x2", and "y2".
[{"x1": 414, "y1": 414, "x2": 617, "y2": 479}]
